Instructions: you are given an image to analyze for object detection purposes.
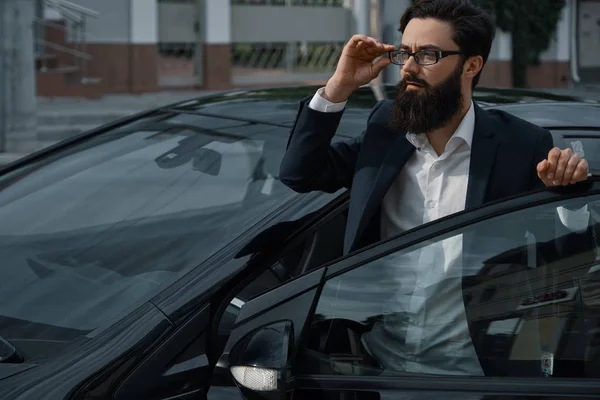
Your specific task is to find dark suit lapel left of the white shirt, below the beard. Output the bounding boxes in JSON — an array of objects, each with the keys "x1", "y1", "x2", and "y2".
[{"x1": 350, "y1": 129, "x2": 415, "y2": 247}]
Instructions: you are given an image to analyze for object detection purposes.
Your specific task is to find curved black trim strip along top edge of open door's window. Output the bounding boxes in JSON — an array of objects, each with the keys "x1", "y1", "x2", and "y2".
[{"x1": 326, "y1": 178, "x2": 600, "y2": 280}]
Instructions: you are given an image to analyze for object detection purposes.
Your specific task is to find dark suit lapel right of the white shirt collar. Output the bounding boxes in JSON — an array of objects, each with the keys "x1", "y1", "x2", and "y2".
[{"x1": 465, "y1": 103, "x2": 498, "y2": 208}]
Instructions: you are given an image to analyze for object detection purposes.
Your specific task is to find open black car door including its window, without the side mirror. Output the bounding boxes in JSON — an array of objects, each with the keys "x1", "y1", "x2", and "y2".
[{"x1": 222, "y1": 182, "x2": 600, "y2": 399}]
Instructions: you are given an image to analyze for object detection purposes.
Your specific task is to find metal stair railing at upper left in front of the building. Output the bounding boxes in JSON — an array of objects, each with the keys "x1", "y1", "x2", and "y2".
[{"x1": 34, "y1": 0, "x2": 100, "y2": 83}]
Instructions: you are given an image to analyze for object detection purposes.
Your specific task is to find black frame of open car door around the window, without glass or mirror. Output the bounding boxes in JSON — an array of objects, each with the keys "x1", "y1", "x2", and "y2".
[{"x1": 218, "y1": 178, "x2": 600, "y2": 396}]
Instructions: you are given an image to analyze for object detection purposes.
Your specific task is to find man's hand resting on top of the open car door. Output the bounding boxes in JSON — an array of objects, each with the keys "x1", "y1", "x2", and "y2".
[{"x1": 537, "y1": 147, "x2": 589, "y2": 187}]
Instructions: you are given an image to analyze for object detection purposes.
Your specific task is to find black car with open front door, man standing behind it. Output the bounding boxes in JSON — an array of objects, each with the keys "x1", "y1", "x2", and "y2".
[{"x1": 0, "y1": 86, "x2": 600, "y2": 400}]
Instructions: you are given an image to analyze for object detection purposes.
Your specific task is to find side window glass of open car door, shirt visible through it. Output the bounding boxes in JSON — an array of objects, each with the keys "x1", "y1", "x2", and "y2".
[{"x1": 295, "y1": 195, "x2": 600, "y2": 378}]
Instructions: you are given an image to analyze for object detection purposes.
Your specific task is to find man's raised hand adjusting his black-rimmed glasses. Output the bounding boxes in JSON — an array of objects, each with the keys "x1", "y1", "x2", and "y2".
[{"x1": 322, "y1": 35, "x2": 395, "y2": 103}]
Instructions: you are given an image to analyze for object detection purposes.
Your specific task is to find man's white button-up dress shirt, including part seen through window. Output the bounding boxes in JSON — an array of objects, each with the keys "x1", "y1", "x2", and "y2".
[{"x1": 309, "y1": 88, "x2": 589, "y2": 376}]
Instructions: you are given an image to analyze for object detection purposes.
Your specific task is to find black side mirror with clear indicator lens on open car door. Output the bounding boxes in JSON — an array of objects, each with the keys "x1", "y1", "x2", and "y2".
[{"x1": 229, "y1": 321, "x2": 294, "y2": 400}]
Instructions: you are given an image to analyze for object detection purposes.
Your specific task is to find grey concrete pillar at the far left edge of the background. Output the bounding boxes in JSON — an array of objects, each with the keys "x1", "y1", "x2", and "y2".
[{"x1": 0, "y1": 0, "x2": 37, "y2": 153}]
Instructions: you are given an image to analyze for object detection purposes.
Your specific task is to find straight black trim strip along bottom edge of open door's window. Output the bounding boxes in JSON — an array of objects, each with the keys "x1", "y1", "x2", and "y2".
[{"x1": 294, "y1": 373, "x2": 600, "y2": 396}]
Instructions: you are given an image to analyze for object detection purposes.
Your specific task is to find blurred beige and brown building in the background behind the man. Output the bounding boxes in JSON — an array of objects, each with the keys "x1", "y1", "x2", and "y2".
[{"x1": 36, "y1": 0, "x2": 600, "y2": 97}]
